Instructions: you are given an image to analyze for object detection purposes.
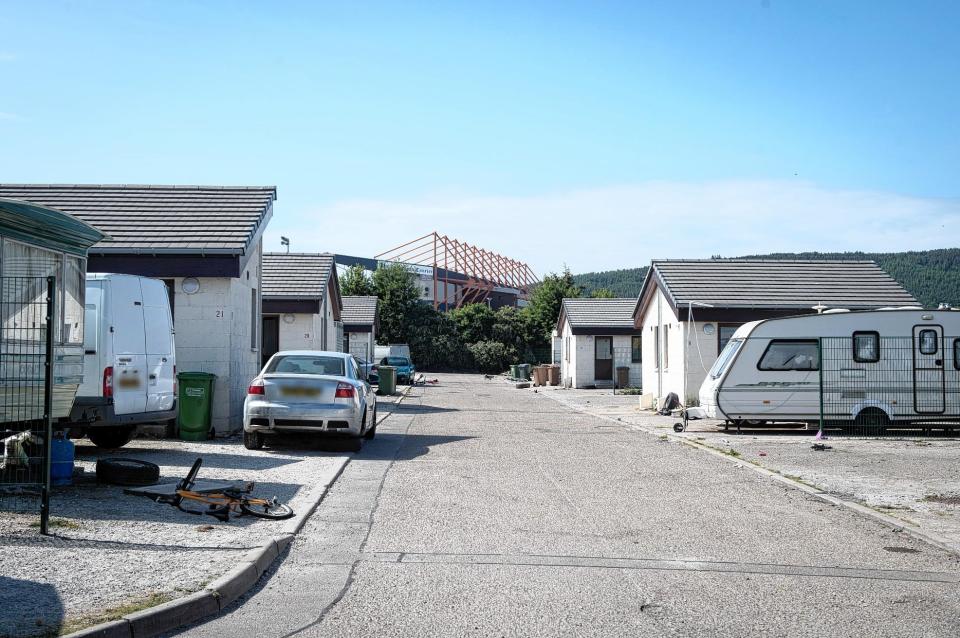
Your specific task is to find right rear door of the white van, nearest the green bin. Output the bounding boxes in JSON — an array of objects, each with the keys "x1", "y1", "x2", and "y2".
[{"x1": 140, "y1": 278, "x2": 176, "y2": 412}]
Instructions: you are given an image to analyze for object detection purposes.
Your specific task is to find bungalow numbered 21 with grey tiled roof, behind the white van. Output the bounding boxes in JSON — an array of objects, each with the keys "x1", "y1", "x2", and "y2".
[{"x1": 0, "y1": 184, "x2": 277, "y2": 434}]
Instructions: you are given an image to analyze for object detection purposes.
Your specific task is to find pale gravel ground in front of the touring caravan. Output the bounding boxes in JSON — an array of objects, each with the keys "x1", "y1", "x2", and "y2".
[{"x1": 540, "y1": 388, "x2": 960, "y2": 552}]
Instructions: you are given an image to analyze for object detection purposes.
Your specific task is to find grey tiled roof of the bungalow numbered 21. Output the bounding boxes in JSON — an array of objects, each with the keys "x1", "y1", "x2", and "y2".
[{"x1": 0, "y1": 184, "x2": 277, "y2": 254}]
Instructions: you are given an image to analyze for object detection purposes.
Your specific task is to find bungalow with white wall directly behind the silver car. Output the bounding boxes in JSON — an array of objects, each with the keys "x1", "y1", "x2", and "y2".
[{"x1": 261, "y1": 253, "x2": 343, "y2": 365}]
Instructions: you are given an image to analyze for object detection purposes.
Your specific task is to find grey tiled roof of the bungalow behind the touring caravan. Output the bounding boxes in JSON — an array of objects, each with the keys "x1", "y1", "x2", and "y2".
[{"x1": 641, "y1": 259, "x2": 917, "y2": 309}]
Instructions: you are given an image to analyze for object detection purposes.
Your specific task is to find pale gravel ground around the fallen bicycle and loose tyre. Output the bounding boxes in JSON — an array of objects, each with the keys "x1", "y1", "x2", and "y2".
[{"x1": 0, "y1": 388, "x2": 408, "y2": 638}]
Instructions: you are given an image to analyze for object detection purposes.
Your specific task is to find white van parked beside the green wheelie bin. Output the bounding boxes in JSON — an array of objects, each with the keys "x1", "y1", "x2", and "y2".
[{"x1": 70, "y1": 274, "x2": 177, "y2": 448}]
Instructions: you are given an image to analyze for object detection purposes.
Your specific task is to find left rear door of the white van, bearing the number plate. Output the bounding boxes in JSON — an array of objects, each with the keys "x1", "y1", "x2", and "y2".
[{"x1": 108, "y1": 275, "x2": 147, "y2": 415}]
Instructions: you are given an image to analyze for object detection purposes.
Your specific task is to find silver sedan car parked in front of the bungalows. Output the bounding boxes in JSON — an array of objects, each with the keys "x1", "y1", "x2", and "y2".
[{"x1": 243, "y1": 350, "x2": 377, "y2": 450}]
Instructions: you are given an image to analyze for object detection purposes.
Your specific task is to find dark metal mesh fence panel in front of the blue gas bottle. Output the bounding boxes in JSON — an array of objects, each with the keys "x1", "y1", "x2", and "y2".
[{"x1": 0, "y1": 277, "x2": 56, "y2": 533}]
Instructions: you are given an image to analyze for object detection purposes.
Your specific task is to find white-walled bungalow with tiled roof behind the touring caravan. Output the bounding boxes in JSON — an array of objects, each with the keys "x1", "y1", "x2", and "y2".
[{"x1": 633, "y1": 259, "x2": 917, "y2": 405}]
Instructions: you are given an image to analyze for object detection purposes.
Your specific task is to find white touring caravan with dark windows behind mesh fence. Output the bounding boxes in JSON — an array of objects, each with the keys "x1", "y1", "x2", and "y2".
[{"x1": 700, "y1": 307, "x2": 960, "y2": 426}]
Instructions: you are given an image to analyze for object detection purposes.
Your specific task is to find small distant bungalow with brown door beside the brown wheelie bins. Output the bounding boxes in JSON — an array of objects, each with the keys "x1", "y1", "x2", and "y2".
[{"x1": 556, "y1": 298, "x2": 642, "y2": 388}]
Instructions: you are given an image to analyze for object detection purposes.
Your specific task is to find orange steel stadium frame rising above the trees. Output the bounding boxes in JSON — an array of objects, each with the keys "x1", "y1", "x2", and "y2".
[{"x1": 374, "y1": 231, "x2": 539, "y2": 308}]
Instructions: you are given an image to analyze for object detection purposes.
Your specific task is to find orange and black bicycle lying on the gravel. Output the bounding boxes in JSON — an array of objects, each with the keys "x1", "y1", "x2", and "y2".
[{"x1": 124, "y1": 458, "x2": 293, "y2": 522}]
